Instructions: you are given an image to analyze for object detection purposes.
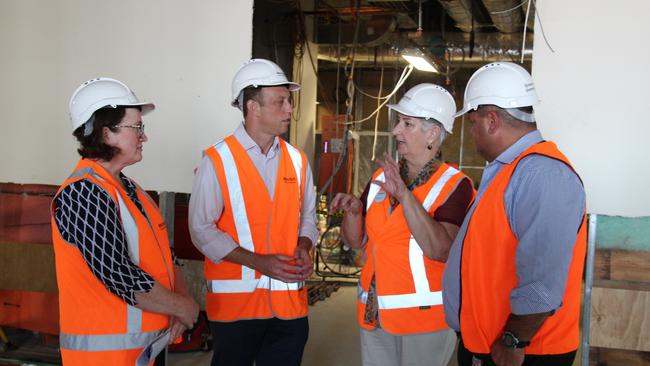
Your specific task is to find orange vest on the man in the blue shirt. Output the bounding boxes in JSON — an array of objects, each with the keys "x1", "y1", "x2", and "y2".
[{"x1": 460, "y1": 142, "x2": 587, "y2": 355}]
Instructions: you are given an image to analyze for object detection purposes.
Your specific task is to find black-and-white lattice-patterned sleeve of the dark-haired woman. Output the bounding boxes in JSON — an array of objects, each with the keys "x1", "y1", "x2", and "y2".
[{"x1": 54, "y1": 180, "x2": 155, "y2": 305}]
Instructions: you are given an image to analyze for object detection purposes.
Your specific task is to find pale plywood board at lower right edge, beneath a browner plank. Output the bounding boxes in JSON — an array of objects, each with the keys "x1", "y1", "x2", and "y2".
[{"x1": 590, "y1": 287, "x2": 650, "y2": 352}]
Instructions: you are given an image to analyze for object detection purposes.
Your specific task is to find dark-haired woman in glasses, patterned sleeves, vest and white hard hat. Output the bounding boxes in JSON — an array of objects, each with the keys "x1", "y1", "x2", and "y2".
[{"x1": 52, "y1": 78, "x2": 199, "y2": 365}]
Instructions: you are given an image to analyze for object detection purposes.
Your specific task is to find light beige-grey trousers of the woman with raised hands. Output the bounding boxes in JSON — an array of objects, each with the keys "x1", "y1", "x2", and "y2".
[{"x1": 359, "y1": 328, "x2": 456, "y2": 366}]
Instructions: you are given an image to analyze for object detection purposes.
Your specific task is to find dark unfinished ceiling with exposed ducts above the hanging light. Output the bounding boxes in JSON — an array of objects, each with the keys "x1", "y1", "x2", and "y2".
[{"x1": 306, "y1": 0, "x2": 535, "y2": 67}]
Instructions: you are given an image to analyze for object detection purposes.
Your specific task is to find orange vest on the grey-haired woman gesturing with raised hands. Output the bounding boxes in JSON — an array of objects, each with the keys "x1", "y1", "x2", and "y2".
[{"x1": 357, "y1": 164, "x2": 469, "y2": 334}]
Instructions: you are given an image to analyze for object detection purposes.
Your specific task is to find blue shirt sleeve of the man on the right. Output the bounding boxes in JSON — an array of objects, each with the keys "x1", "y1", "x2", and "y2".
[{"x1": 504, "y1": 155, "x2": 585, "y2": 315}]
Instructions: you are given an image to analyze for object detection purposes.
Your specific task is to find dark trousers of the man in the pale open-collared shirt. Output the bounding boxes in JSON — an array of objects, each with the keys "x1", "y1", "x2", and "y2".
[{"x1": 210, "y1": 317, "x2": 309, "y2": 366}]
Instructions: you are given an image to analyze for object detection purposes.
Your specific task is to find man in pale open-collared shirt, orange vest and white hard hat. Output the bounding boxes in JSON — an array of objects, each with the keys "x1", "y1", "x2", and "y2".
[{"x1": 189, "y1": 59, "x2": 318, "y2": 366}]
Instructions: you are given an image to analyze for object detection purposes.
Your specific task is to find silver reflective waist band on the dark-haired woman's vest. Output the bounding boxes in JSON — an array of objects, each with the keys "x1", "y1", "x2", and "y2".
[{"x1": 59, "y1": 330, "x2": 165, "y2": 351}]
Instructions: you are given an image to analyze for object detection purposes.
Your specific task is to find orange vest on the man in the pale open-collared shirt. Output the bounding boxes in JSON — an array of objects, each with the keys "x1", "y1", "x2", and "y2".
[{"x1": 204, "y1": 136, "x2": 311, "y2": 321}]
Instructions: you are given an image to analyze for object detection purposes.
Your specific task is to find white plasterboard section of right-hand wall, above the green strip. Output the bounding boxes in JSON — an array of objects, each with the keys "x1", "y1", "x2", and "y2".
[{"x1": 532, "y1": 0, "x2": 650, "y2": 217}]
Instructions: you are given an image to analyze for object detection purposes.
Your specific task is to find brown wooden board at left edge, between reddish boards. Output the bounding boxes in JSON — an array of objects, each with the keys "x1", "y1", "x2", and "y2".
[{"x1": 0, "y1": 242, "x2": 58, "y2": 292}]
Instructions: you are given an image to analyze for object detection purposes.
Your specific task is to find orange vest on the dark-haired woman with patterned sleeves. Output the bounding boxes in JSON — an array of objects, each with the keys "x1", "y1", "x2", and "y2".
[{"x1": 51, "y1": 159, "x2": 174, "y2": 366}]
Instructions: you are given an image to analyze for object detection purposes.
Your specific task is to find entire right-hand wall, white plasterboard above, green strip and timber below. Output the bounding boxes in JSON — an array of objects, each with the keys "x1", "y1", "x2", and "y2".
[{"x1": 533, "y1": 0, "x2": 650, "y2": 365}]
